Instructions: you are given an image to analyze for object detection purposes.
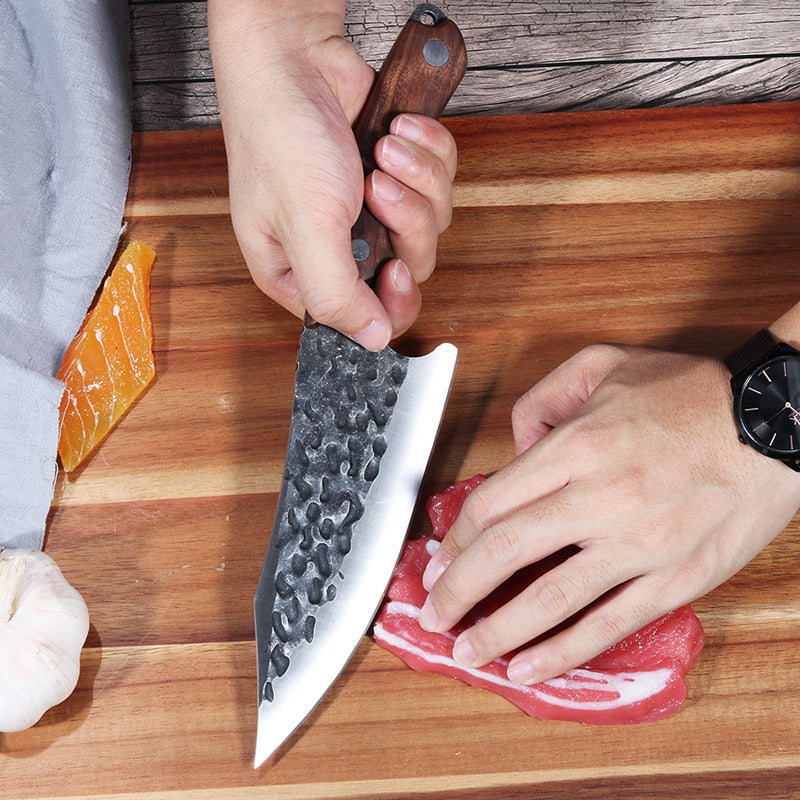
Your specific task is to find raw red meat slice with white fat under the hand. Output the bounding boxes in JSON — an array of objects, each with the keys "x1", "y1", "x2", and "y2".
[{"x1": 374, "y1": 476, "x2": 704, "y2": 725}]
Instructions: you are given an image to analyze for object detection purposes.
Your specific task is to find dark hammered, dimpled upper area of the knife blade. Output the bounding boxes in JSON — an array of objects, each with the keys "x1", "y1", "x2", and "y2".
[{"x1": 257, "y1": 325, "x2": 408, "y2": 701}]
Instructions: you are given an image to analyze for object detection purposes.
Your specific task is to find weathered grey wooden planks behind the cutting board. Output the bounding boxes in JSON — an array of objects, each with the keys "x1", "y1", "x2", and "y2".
[{"x1": 130, "y1": 0, "x2": 800, "y2": 130}]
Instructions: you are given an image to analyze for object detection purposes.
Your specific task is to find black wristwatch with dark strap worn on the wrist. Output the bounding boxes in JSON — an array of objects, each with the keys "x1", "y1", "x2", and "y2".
[{"x1": 725, "y1": 330, "x2": 800, "y2": 472}]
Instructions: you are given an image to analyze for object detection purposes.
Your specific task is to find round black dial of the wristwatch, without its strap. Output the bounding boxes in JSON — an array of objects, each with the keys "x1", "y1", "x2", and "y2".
[{"x1": 736, "y1": 355, "x2": 800, "y2": 458}]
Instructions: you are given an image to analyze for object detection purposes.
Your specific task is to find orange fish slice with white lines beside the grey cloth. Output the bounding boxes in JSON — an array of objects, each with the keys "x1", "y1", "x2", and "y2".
[{"x1": 57, "y1": 242, "x2": 156, "y2": 472}]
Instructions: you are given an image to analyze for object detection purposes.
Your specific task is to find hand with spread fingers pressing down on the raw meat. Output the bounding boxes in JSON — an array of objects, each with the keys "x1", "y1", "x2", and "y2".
[{"x1": 420, "y1": 340, "x2": 800, "y2": 684}]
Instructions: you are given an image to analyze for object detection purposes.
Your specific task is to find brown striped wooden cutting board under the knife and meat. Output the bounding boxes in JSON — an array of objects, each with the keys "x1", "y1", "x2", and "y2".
[{"x1": 0, "y1": 105, "x2": 800, "y2": 800}]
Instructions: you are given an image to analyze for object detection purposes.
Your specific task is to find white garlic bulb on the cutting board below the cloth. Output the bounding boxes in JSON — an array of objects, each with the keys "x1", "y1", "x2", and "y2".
[{"x1": 0, "y1": 547, "x2": 89, "y2": 733}]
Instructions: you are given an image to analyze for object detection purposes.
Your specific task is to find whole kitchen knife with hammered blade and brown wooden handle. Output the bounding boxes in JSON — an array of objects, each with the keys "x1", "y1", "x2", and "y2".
[{"x1": 254, "y1": 3, "x2": 466, "y2": 767}]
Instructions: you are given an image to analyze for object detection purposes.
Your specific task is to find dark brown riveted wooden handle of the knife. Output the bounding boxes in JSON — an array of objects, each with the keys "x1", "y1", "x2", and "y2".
[{"x1": 352, "y1": 3, "x2": 467, "y2": 284}]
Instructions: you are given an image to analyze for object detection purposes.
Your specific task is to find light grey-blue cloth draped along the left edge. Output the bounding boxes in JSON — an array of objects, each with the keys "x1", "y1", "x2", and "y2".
[{"x1": 0, "y1": 0, "x2": 131, "y2": 548}]
